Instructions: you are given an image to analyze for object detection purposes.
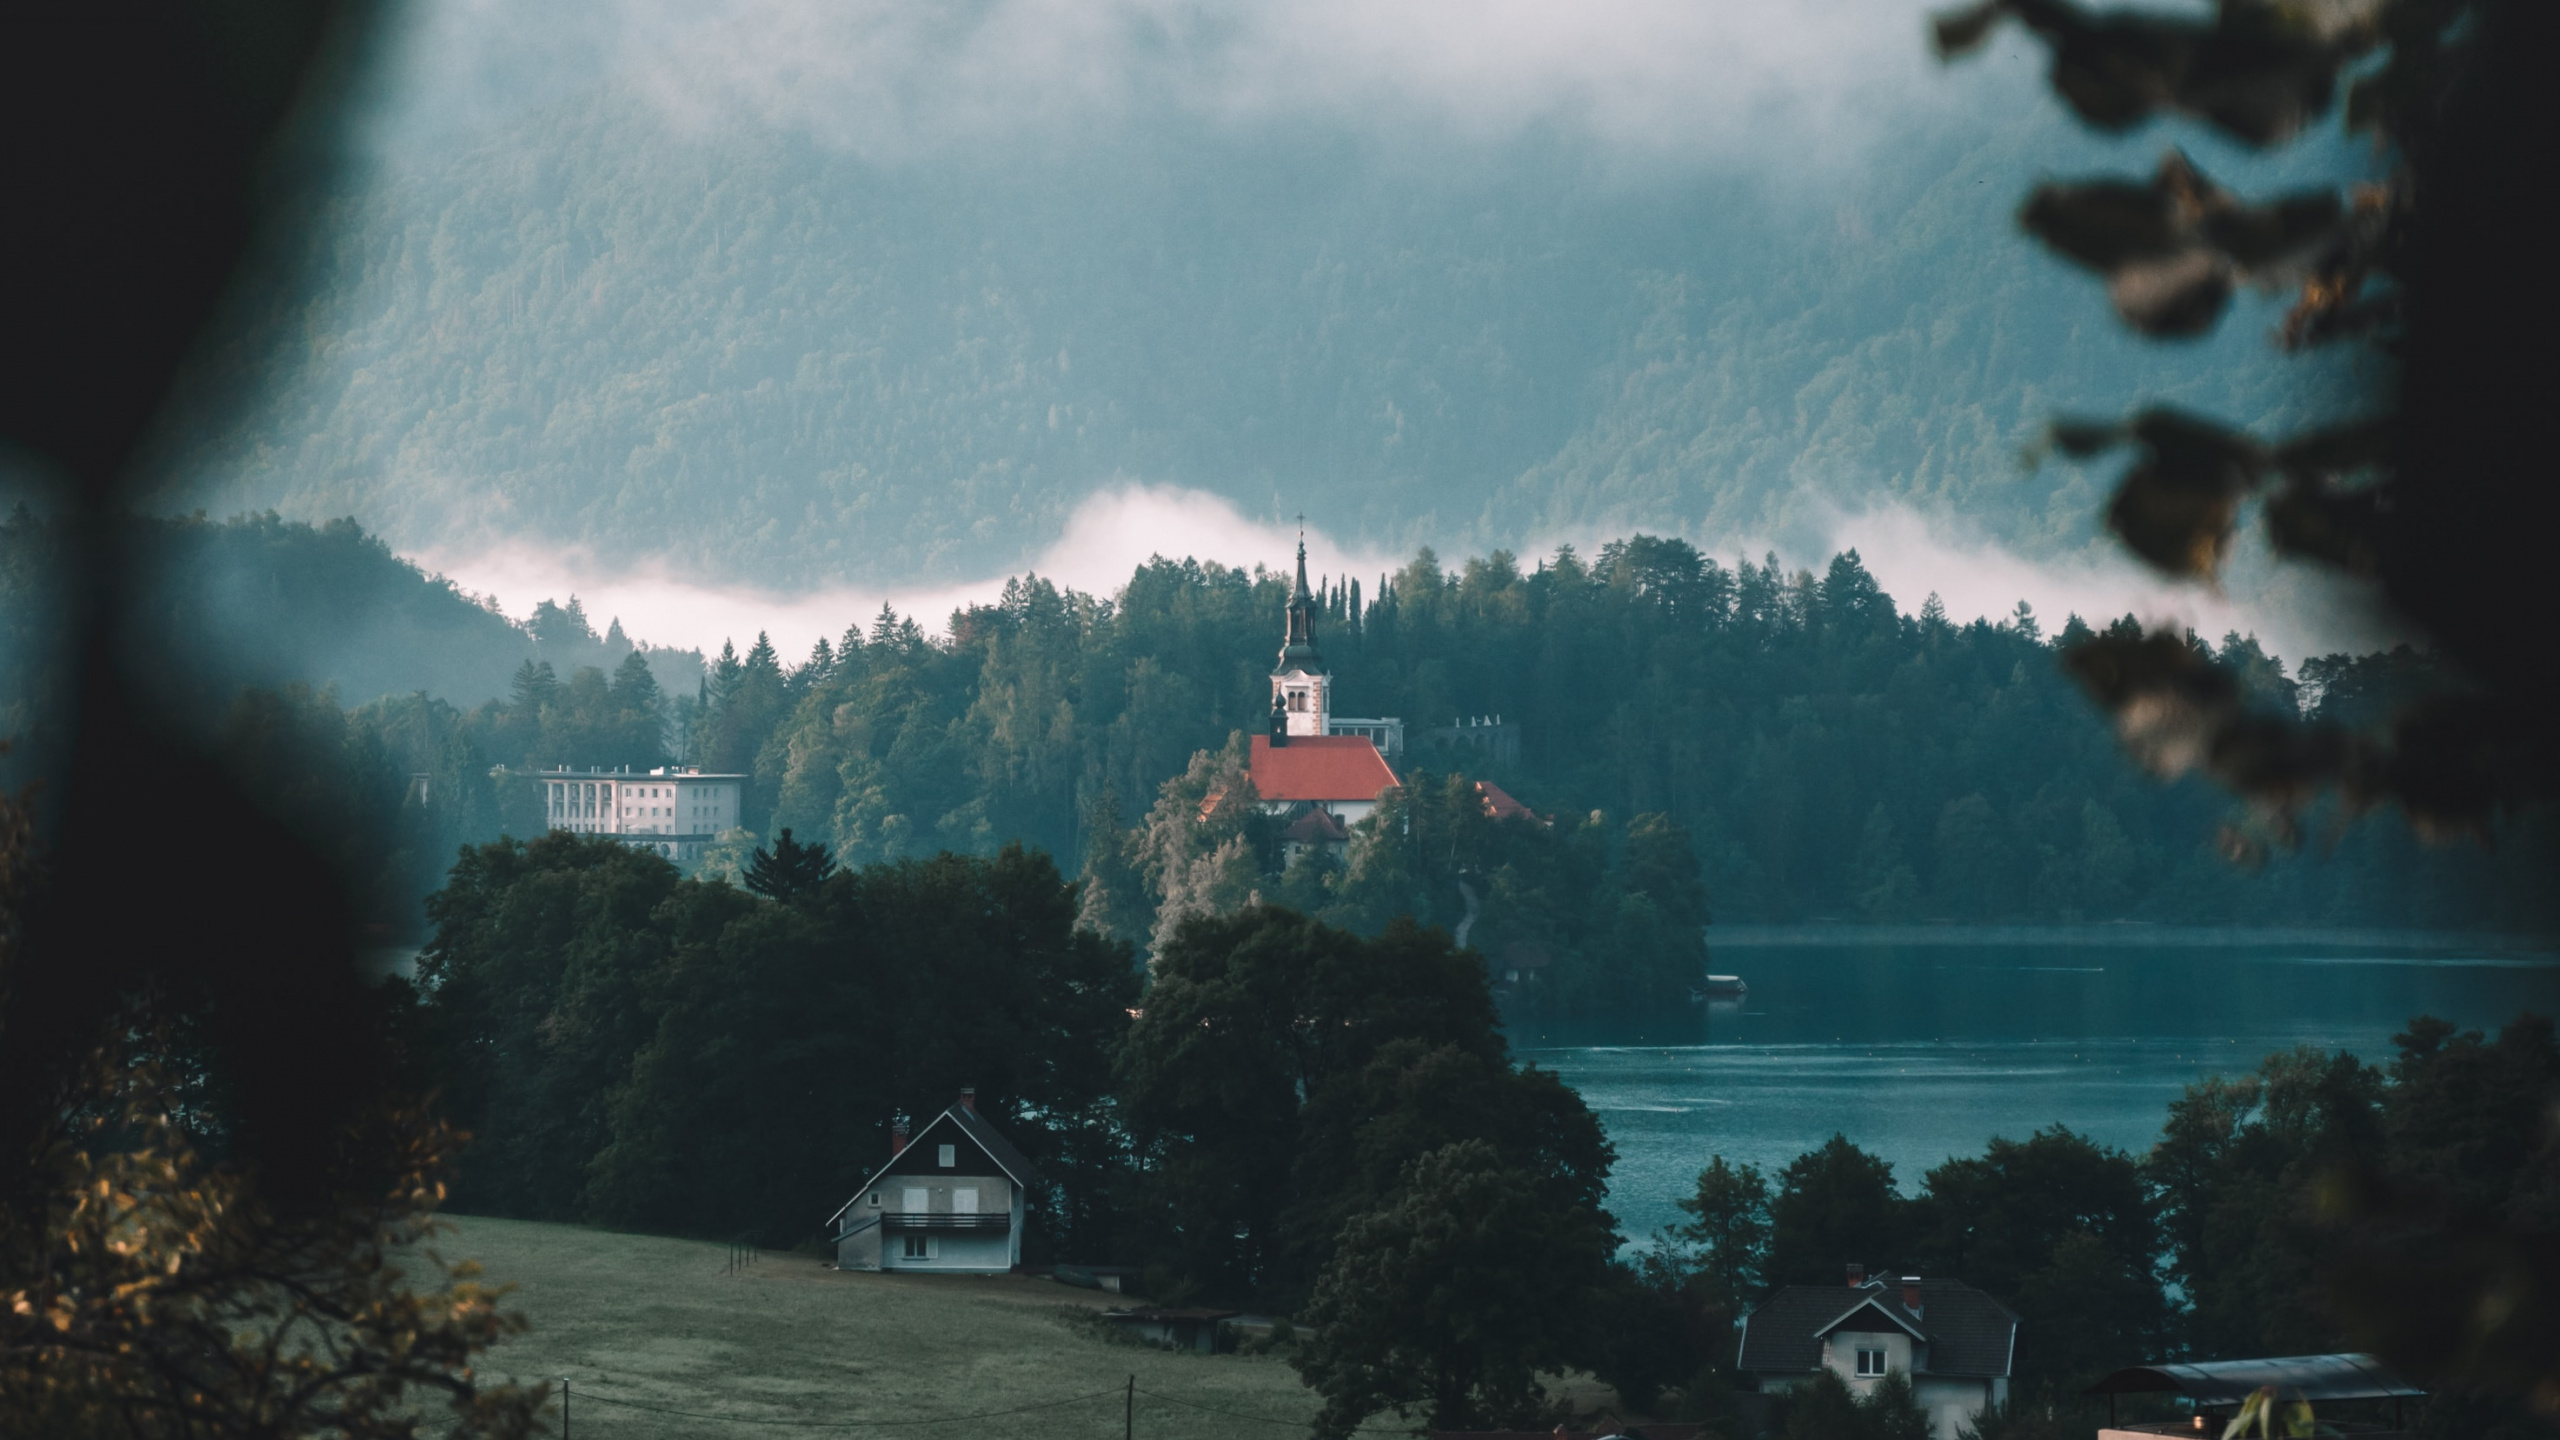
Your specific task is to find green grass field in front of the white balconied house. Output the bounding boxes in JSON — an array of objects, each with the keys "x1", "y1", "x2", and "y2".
[{"x1": 435, "y1": 1217, "x2": 1341, "y2": 1440}]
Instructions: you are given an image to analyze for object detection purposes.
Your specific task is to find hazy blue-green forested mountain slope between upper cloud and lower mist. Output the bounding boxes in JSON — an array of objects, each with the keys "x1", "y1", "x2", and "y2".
[{"x1": 166, "y1": 90, "x2": 2340, "y2": 584}]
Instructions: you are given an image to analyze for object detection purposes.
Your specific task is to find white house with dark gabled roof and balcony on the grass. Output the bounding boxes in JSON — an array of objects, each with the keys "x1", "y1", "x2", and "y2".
[{"x1": 827, "y1": 1089, "x2": 1039, "y2": 1276}]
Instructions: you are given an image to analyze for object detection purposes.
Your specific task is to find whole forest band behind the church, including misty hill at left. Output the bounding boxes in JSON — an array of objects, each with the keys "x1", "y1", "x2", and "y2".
[{"x1": 15, "y1": 518, "x2": 2555, "y2": 948}]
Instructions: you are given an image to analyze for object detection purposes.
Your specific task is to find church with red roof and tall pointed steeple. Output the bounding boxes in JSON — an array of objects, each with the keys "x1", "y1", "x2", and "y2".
[{"x1": 1252, "y1": 538, "x2": 1405, "y2": 863}]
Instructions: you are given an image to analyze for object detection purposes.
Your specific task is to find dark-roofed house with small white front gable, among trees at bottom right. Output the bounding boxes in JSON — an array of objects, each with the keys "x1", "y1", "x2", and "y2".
[{"x1": 1733, "y1": 1266, "x2": 2017, "y2": 1440}]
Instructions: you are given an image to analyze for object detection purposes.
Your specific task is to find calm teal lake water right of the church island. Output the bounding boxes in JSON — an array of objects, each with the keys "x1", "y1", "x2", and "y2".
[{"x1": 1510, "y1": 928, "x2": 2560, "y2": 1240}]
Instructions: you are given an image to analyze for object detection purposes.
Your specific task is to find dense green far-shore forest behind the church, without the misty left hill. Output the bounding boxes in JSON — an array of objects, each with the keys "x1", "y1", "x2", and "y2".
[{"x1": 586, "y1": 536, "x2": 2550, "y2": 940}]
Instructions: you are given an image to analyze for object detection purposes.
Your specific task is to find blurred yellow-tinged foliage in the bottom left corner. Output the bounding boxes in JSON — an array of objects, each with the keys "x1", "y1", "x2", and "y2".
[{"x1": 0, "y1": 784, "x2": 543, "y2": 1440}]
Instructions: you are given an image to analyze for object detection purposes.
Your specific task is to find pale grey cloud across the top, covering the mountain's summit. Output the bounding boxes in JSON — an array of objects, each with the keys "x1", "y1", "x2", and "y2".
[{"x1": 366, "y1": 0, "x2": 2033, "y2": 169}]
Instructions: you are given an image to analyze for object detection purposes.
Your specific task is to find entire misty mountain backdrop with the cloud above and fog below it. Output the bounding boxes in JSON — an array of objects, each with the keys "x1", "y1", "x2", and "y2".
[{"x1": 140, "y1": 0, "x2": 2383, "y2": 645}]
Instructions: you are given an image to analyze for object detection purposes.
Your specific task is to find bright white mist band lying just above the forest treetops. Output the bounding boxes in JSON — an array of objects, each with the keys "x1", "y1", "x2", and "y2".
[{"x1": 417, "y1": 487, "x2": 2391, "y2": 661}]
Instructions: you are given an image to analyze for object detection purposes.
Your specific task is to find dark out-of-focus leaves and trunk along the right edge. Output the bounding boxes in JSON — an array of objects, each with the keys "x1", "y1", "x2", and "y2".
[{"x1": 1935, "y1": 0, "x2": 2560, "y2": 1414}]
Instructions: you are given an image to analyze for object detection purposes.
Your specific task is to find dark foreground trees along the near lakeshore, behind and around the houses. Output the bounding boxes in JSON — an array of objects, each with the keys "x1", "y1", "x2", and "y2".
[{"x1": 404, "y1": 835, "x2": 2560, "y2": 1440}]
